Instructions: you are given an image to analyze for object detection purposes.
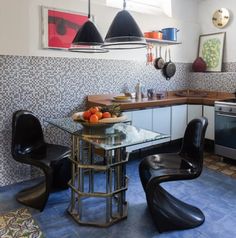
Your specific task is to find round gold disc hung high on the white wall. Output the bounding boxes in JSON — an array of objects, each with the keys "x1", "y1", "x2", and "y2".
[{"x1": 212, "y1": 8, "x2": 230, "y2": 28}]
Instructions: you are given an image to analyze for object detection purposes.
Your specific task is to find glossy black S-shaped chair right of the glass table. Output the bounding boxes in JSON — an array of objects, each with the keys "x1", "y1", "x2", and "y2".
[{"x1": 139, "y1": 117, "x2": 208, "y2": 232}]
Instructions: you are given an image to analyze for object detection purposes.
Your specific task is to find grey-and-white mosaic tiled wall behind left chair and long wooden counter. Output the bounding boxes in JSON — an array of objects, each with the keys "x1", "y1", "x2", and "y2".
[{"x1": 0, "y1": 56, "x2": 190, "y2": 186}]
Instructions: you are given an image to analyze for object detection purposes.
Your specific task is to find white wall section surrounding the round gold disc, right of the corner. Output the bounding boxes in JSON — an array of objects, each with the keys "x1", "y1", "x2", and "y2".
[{"x1": 198, "y1": 0, "x2": 236, "y2": 62}]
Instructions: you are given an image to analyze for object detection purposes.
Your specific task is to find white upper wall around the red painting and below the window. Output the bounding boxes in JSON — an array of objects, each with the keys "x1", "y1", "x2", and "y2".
[{"x1": 0, "y1": 0, "x2": 199, "y2": 62}]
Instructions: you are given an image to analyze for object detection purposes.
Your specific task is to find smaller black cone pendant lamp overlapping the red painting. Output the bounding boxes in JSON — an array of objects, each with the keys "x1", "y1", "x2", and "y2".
[{"x1": 69, "y1": 0, "x2": 108, "y2": 53}]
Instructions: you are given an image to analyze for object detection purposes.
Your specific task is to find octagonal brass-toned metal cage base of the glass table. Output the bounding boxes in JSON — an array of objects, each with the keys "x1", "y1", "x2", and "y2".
[{"x1": 68, "y1": 135, "x2": 129, "y2": 227}]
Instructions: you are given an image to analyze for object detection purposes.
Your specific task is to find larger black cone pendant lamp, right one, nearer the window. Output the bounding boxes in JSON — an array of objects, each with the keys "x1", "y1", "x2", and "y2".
[{"x1": 102, "y1": 0, "x2": 147, "y2": 50}]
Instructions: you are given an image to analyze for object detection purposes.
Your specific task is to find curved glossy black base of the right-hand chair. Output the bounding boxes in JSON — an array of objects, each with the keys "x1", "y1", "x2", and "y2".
[{"x1": 147, "y1": 185, "x2": 205, "y2": 232}]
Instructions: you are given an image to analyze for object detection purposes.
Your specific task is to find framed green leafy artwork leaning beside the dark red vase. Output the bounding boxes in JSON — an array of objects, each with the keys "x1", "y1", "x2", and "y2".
[{"x1": 198, "y1": 32, "x2": 225, "y2": 72}]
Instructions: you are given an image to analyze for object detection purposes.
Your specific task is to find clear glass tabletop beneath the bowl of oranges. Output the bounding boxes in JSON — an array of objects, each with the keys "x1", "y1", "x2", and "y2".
[{"x1": 47, "y1": 117, "x2": 169, "y2": 150}]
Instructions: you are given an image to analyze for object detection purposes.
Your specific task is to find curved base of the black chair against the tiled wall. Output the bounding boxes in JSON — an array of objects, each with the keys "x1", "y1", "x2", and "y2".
[{"x1": 16, "y1": 181, "x2": 49, "y2": 211}]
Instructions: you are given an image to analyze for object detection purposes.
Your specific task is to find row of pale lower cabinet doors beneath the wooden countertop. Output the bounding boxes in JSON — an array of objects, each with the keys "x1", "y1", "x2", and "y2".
[{"x1": 124, "y1": 104, "x2": 214, "y2": 152}]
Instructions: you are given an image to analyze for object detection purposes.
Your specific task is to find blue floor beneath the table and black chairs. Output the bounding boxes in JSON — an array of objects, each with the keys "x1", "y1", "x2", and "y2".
[{"x1": 0, "y1": 160, "x2": 236, "y2": 238}]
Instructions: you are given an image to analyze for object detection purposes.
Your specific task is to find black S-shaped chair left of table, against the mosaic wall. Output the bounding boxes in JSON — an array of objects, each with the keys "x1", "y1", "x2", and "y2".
[{"x1": 11, "y1": 110, "x2": 71, "y2": 211}]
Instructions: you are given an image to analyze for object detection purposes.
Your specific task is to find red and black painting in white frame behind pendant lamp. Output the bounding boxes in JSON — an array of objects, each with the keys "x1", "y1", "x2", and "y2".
[{"x1": 41, "y1": 6, "x2": 90, "y2": 50}]
